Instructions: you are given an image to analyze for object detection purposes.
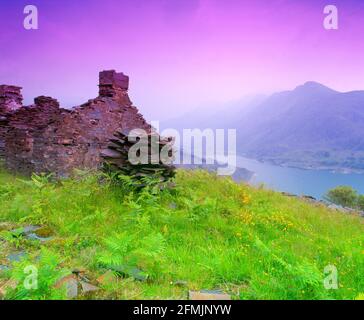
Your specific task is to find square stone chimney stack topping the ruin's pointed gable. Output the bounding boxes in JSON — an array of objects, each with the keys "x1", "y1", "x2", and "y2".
[{"x1": 99, "y1": 70, "x2": 129, "y2": 98}]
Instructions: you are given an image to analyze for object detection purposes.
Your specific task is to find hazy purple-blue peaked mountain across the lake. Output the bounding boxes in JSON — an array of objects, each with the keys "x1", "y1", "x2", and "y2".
[{"x1": 235, "y1": 81, "x2": 364, "y2": 171}]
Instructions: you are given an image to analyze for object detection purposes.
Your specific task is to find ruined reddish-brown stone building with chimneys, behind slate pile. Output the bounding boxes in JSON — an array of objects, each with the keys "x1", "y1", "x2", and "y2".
[{"x1": 0, "y1": 70, "x2": 150, "y2": 176}]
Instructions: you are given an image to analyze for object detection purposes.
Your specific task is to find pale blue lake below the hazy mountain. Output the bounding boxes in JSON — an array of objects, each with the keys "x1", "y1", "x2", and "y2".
[{"x1": 237, "y1": 156, "x2": 364, "y2": 199}]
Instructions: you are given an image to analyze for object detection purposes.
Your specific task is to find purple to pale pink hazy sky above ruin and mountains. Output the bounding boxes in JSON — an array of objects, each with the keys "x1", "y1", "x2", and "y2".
[{"x1": 0, "y1": 0, "x2": 364, "y2": 120}]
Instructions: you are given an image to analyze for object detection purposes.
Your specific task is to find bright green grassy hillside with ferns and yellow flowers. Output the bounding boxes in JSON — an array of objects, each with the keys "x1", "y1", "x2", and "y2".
[{"x1": 0, "y1": 170, "x2": 364, "y2": 299}]
